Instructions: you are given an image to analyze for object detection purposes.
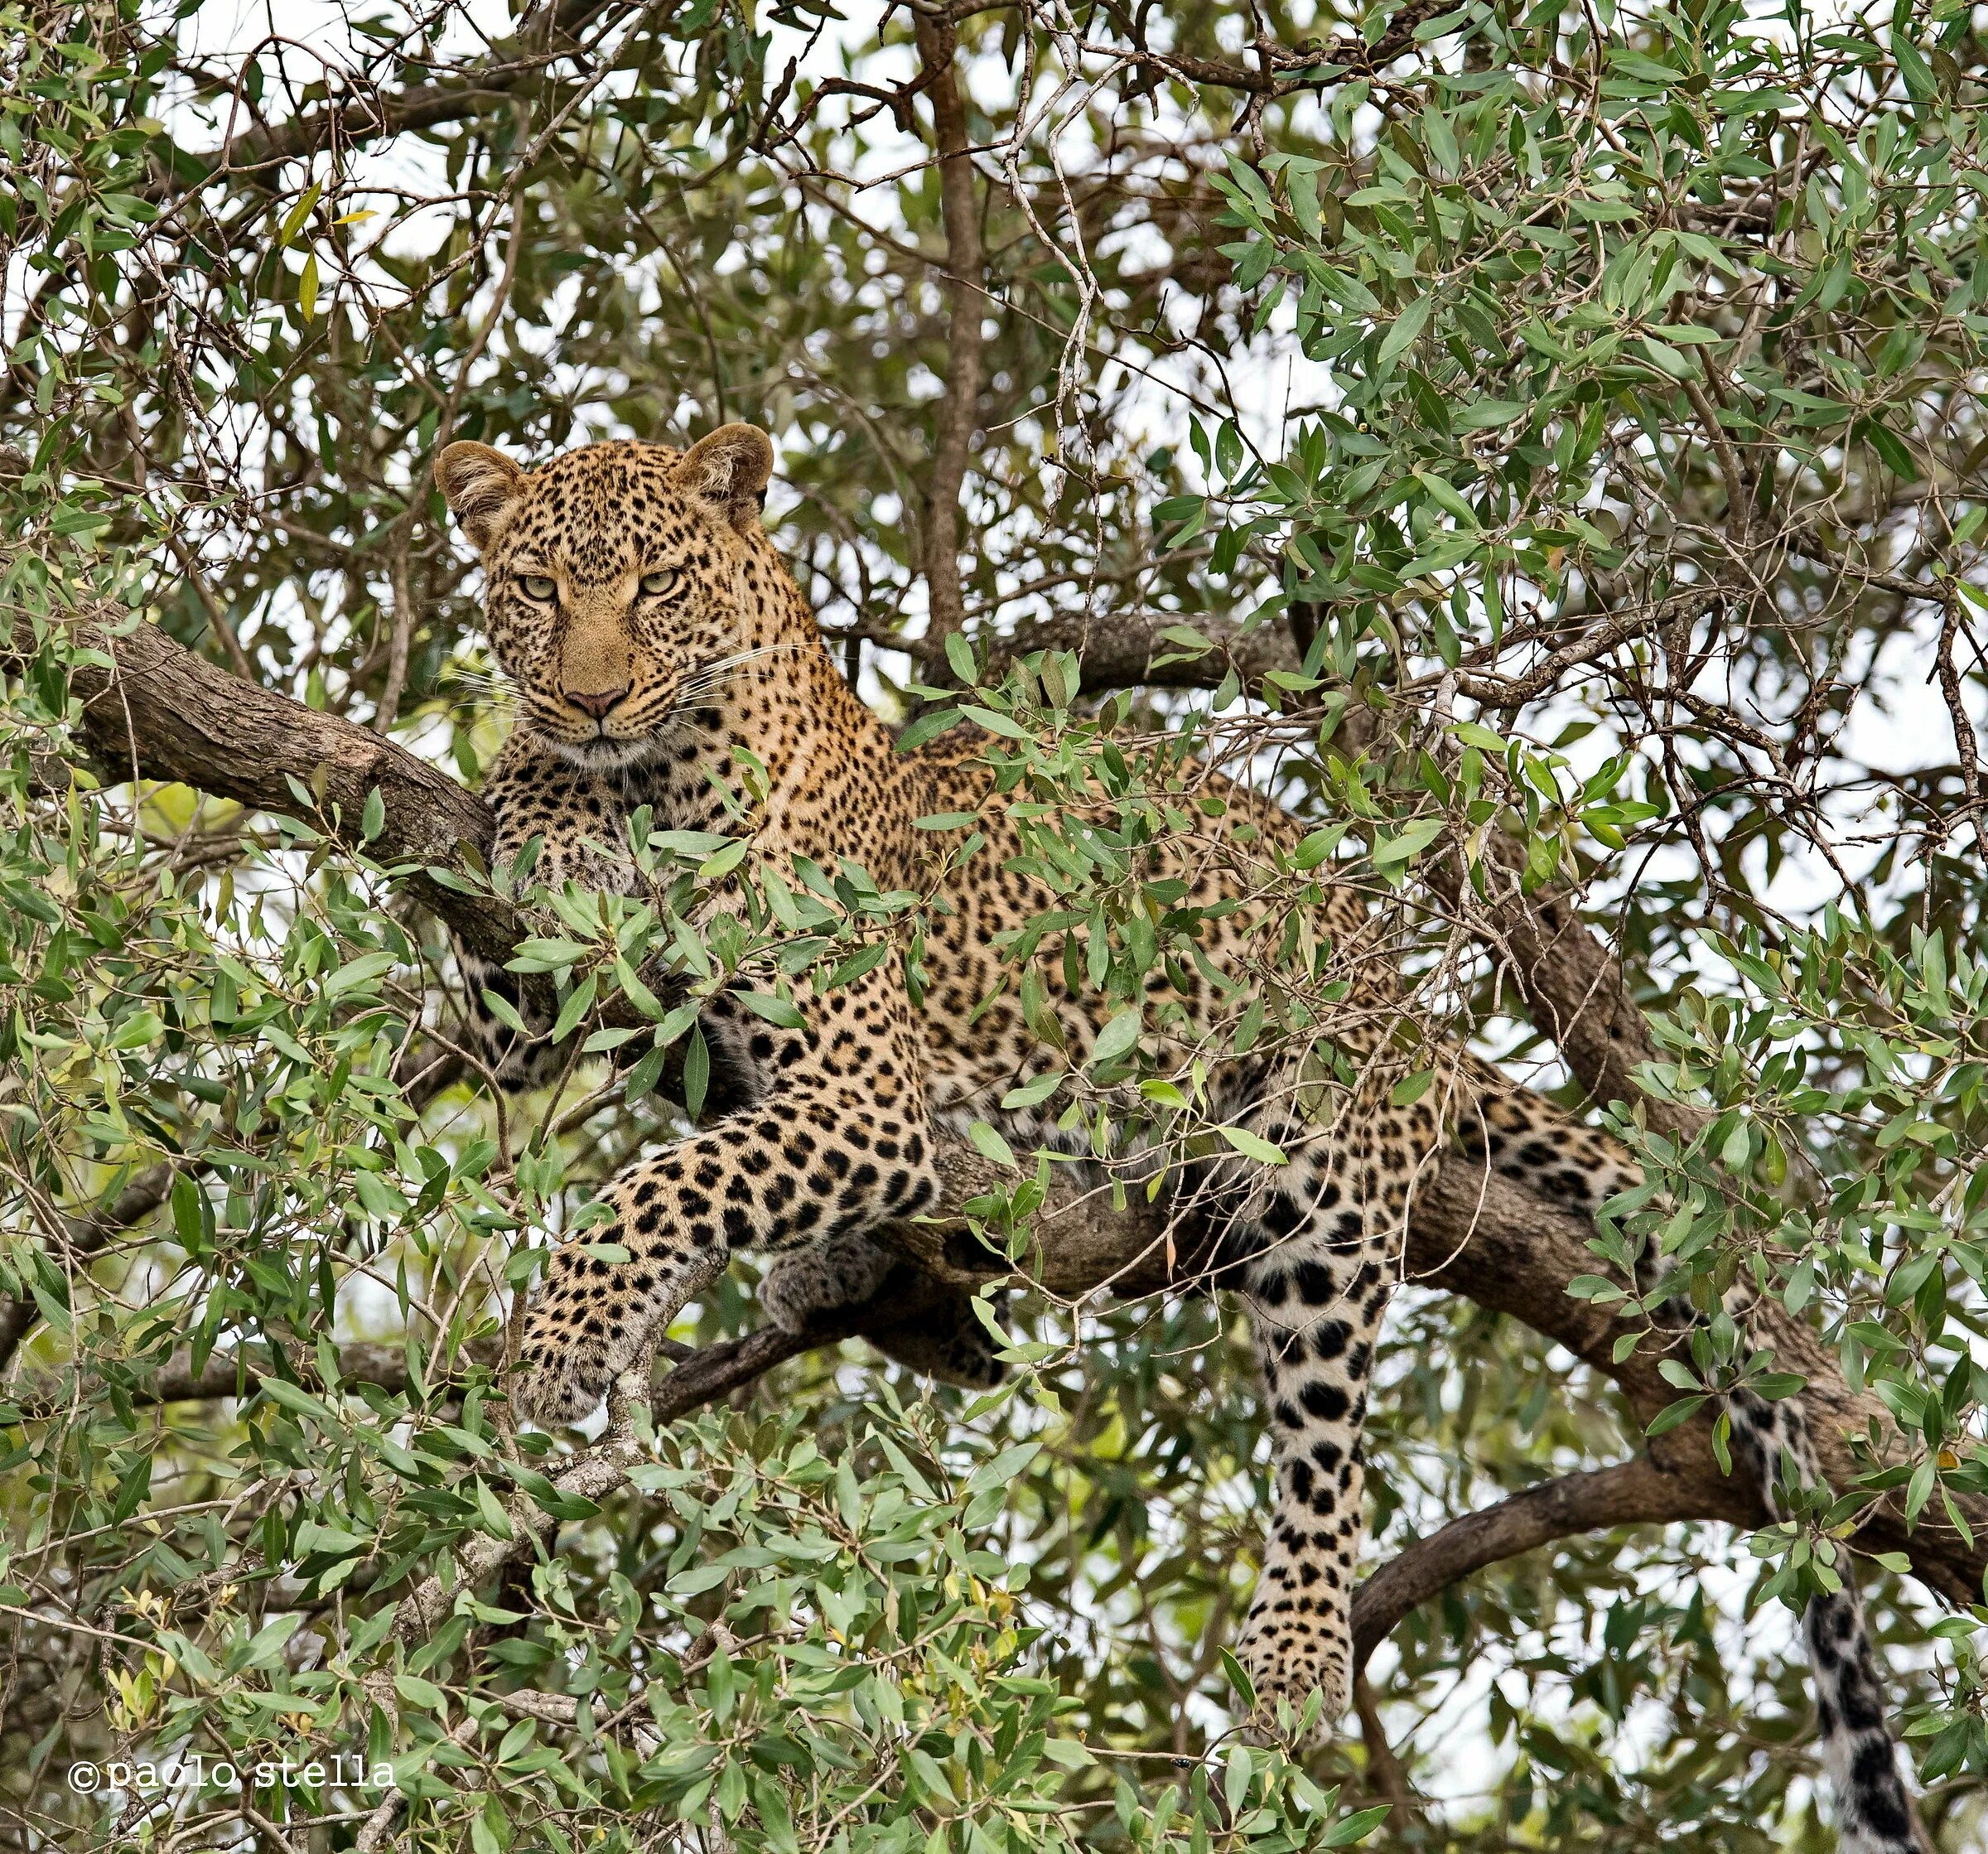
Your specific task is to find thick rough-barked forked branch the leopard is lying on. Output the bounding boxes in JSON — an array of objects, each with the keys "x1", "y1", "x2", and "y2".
[{"x1": 19, "y1": 625, "x2": 1988, "y2": 1663}]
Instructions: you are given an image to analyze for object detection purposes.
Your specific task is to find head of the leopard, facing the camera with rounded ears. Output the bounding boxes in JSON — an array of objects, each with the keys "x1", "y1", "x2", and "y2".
[{"x1": 436, "y1": 426, "x2": 774, "y2": 768}]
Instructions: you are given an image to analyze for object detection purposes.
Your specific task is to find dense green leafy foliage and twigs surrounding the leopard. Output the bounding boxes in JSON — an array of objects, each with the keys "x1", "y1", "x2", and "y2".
[{"x1": 0, "y1": 0, "x2": 1988, "y2": 1854}]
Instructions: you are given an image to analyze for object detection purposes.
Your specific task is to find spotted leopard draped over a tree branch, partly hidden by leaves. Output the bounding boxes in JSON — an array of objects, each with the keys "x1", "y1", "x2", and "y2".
[{"x1": 436, "y1": 423, "x2": 1914, "y2": 1854}]
